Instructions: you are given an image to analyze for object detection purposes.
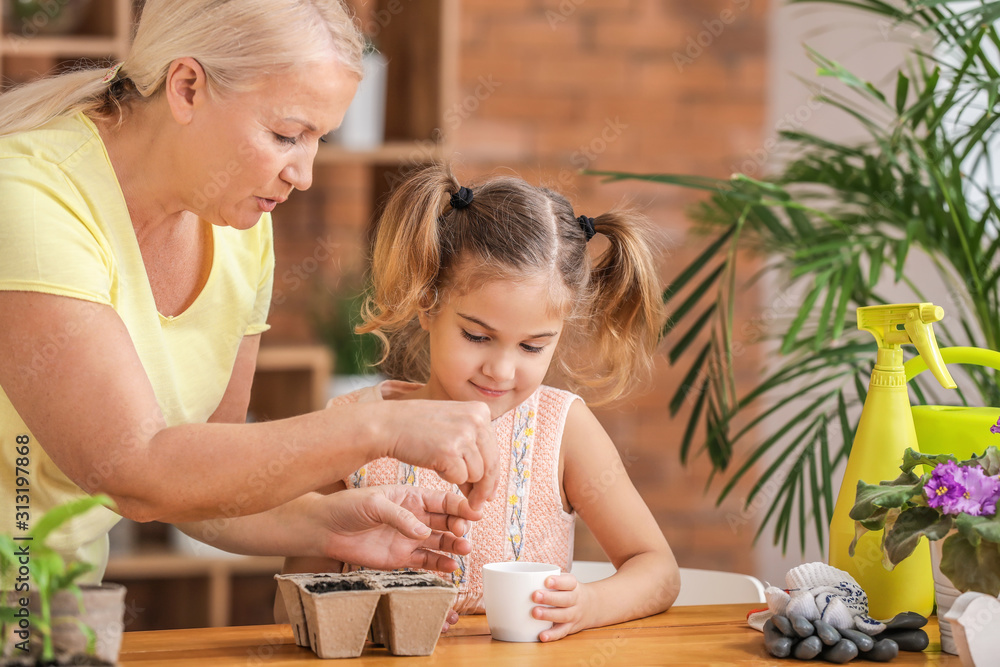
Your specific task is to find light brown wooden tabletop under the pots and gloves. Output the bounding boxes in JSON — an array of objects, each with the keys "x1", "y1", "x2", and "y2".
[{"x1": 121, "y1": 604, "x2": 961, "y2": 667}]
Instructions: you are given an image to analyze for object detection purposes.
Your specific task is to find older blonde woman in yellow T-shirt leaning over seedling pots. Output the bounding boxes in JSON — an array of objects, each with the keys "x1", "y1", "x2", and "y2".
[{"x1": 0, "y1": 0, "x2": 496, "y2": 578}]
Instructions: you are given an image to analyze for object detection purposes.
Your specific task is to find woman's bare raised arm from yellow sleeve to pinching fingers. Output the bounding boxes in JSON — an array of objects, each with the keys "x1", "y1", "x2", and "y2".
[{"x1": 0, "y1": 291, "x2": 496, "y2": 522}]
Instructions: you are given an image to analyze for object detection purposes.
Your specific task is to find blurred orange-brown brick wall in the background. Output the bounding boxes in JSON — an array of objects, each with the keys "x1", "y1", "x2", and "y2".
[{"x1": 268, "y1": 0, "x2": 767, "y2": 572}]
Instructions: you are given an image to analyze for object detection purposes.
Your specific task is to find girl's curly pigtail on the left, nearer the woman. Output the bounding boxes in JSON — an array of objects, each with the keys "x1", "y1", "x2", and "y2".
[{"x1": 356, "y1": 166, "x2": 458, "y2": 381}]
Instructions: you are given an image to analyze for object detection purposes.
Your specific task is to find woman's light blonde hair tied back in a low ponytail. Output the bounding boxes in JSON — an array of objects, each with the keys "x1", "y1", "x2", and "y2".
[{"x1": 0, "y1": 0, "x2": 364, "y2": 136}]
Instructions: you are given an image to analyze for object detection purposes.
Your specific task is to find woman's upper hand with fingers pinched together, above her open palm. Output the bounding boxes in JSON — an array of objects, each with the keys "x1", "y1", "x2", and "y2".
[{"x1": 372, "y1": 400, "x2": 499, "y2": 510}]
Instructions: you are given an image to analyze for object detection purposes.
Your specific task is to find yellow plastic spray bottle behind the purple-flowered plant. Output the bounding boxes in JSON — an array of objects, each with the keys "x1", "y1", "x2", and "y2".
[{"x1": 830, "y1": 303, "x2": 955, "y2": 619}]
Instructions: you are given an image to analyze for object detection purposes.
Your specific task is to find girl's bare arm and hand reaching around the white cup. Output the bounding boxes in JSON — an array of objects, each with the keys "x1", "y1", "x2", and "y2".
[{"x1": 533, "y1": 401, "x2": 680, "y2": 641}]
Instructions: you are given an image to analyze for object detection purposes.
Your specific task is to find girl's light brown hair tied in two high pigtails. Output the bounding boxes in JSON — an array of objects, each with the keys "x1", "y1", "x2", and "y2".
[{"x1": 357, "y1": 165, "x2": 664, "y2": 403}]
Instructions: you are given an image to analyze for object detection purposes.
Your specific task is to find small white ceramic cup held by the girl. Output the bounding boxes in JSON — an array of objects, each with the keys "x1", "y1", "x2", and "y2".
[{"x1": 483, "y1": 562, "x2": 562, "y2": 642}]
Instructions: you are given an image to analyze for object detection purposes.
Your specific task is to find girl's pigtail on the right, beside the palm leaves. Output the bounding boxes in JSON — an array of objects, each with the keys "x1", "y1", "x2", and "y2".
[{"x1": 576, "y1": 211, "x2": 664, "y2": 403}]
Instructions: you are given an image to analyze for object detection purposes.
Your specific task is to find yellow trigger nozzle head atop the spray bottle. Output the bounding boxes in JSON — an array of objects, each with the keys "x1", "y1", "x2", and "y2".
[{"x1": 858, "y1": 303, "x2": 957, "y2": 389}]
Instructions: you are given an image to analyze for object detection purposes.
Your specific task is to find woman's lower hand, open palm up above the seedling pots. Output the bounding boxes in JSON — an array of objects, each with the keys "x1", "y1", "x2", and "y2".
[{"x1": 319, "y1": 486, "x2": 482, "y2": 572}]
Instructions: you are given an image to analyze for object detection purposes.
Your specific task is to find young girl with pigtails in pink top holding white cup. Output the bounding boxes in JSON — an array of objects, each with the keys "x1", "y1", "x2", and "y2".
[{"x1": 285, "y1": 167, "x2": 680, "y2": 641}]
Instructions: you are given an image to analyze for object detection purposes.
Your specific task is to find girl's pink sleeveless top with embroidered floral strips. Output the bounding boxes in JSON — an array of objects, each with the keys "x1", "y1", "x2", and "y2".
[{"x1": 331, "y1": 380, "x2": 579, "y2": 614}]
